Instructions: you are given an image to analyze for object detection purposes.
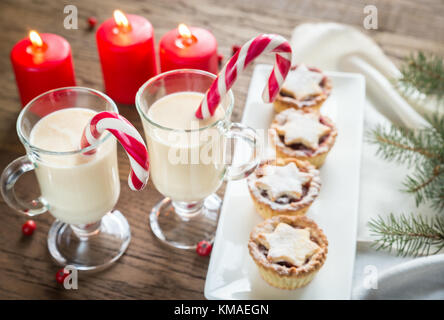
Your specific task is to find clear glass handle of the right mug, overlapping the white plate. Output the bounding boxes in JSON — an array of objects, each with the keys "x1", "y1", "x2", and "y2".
[{"x1": 224, "y1": 122, "x2": 262, "y2": 180}]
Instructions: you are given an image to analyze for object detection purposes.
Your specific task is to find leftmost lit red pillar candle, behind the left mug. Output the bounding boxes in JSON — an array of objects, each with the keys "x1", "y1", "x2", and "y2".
[{"x1": 11, "y1": 31, "x2": 76, "y2": 106}]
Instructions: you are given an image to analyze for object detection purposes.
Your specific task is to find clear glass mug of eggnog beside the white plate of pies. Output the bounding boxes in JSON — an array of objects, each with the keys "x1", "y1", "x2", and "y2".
[{"x1": 136, "y1": 69, "x2": 260, "y2": 249}]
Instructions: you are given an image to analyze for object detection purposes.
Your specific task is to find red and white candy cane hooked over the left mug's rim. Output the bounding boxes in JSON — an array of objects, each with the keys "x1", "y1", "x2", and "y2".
[{"x1": 80, "y1": 111, "x2": 149, "y2": 191}]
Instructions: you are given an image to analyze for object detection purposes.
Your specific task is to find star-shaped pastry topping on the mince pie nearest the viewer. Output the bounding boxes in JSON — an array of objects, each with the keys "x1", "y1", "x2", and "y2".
[{"x1": 259, "y1": 223, "x2": 319, "y2": 267}]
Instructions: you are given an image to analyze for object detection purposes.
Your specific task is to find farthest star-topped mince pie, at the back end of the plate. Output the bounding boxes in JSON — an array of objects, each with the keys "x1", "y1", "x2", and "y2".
[{"x1": 274, "y1": 64, "x2": 332, "y2": 112}]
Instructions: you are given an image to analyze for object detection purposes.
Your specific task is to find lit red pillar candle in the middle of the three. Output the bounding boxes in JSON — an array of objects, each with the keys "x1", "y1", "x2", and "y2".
[{"x1": 96, "y1": 10, "x2": 157, "y2": 104}]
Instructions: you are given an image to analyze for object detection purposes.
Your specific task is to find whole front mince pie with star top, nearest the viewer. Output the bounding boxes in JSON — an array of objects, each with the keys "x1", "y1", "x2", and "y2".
[{"x1": 248, "y1": 216, "x2": 328, "y2": 289}]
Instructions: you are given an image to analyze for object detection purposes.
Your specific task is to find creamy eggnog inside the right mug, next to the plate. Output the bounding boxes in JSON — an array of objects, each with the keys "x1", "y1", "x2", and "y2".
[{"x1": 143, "y1": 92, "x2": 225, "y2": 202}]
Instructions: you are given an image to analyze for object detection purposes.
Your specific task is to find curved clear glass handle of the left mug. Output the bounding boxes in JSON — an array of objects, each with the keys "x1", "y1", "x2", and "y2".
[{"x1": 0, "y1": 156, "x2": 48, "y2": 217}]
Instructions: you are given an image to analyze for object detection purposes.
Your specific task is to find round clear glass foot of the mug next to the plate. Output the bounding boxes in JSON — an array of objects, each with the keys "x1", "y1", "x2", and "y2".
[{"x1": 150, "y1": 194, "x2": 222, "y2": 249}]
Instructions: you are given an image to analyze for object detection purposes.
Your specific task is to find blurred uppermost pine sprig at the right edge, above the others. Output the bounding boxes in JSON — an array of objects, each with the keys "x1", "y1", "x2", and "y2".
[{"x1": 398, "y1": 52, "x2": 444, "y2": 100}]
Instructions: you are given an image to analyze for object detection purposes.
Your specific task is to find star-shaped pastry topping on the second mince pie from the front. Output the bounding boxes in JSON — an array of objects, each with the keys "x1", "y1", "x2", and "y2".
[{"x1": 256, "y1": 162, "x2": 311, "y2": 201}]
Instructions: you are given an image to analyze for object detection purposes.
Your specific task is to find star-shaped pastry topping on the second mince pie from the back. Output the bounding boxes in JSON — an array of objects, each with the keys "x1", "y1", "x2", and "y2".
[{"x1": 273, "y1": 109, "x2": 331, "y2": 150}]
